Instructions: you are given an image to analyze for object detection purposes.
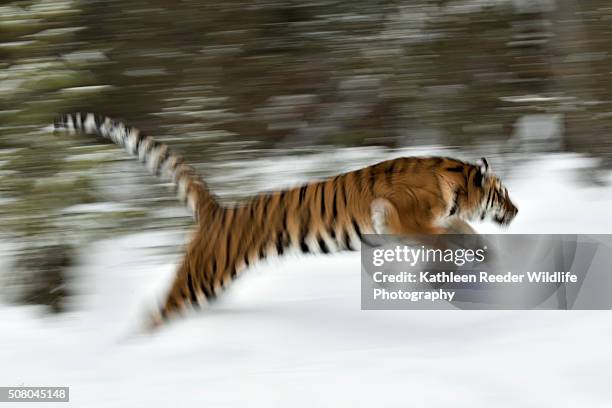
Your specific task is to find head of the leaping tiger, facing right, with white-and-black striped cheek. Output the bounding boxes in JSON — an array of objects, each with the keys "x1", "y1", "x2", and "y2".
[{"x1": 471, "y1": 157, "x2": 518, "y2": 225}]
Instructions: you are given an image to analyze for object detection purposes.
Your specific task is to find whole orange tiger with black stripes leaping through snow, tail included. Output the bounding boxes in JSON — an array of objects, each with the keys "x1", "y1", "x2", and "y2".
[{"x1": 52, "y1": 113, "x2": 518, "y2": 329}]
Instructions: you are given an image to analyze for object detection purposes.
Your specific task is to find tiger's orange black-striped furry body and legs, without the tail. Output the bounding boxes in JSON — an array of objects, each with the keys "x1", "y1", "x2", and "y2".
[{"x1": 153, "y1": 157, "x2": 517, "y2": 326}]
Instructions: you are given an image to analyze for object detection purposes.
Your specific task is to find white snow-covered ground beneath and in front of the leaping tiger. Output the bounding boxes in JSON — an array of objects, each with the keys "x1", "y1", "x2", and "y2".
[{"x1": 0, "y1": 151, "x2": 612, "y2": 408}]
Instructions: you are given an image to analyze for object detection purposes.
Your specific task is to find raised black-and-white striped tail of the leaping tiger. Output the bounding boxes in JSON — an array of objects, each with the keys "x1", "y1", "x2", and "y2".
[{"x1": 53, "y1": 113, "x2": 219, "y2": 223}]
